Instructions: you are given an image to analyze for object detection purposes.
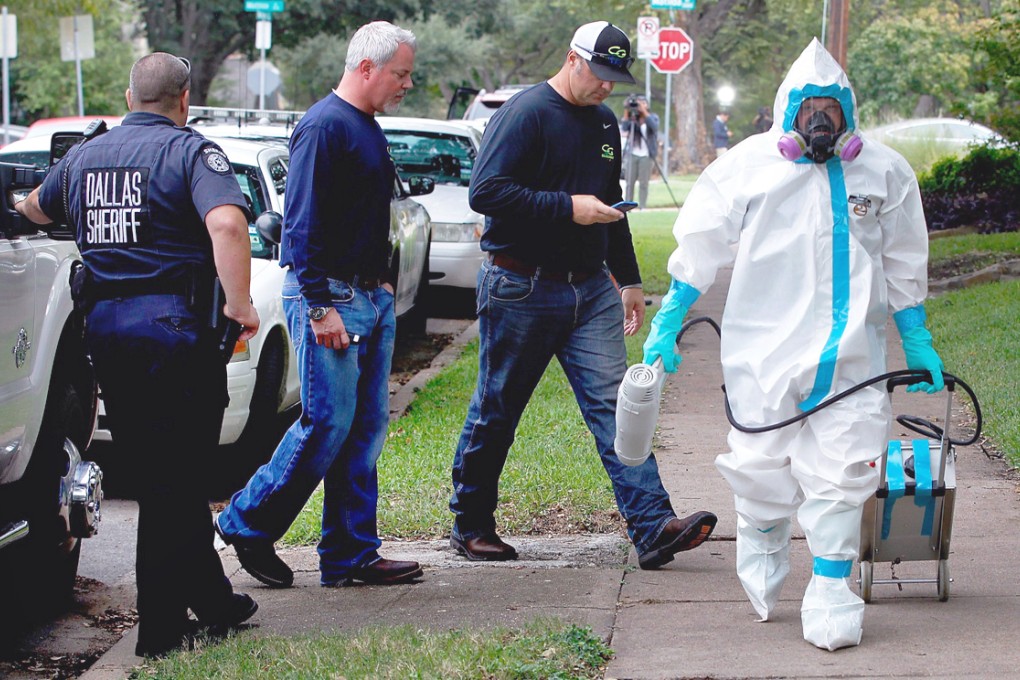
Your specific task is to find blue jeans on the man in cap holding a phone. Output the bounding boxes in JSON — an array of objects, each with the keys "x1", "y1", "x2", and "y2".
[{"x1": 450, "y1": 262, "x2": 675, "y2": 554}]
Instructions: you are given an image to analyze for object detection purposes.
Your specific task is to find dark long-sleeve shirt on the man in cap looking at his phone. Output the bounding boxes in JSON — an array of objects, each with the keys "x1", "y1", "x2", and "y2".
[{"x1": 469, "y1": 83, "x2": 641, "y2": 285}]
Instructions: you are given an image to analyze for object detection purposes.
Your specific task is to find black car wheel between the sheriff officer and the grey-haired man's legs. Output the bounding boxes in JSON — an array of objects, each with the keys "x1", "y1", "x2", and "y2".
[{"x1": 237, "y1": 332, "x2": 287, "y2": 471}]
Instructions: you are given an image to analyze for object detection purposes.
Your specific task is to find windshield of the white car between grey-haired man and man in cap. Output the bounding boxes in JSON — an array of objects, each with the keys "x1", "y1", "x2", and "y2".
[{"x1": 384, "y1": 129, "x2": 475, "y2": 187}]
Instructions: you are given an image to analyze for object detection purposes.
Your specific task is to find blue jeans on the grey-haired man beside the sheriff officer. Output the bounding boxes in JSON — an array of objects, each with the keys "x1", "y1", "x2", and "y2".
[{"x1": 219, "y1": 271, "x2": 396, "y2": 583}]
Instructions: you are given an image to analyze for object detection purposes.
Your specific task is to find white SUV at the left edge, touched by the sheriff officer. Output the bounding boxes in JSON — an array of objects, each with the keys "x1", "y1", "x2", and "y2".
[{"x1": 0, "y1": 163, "x2": 102, "y2": 625}]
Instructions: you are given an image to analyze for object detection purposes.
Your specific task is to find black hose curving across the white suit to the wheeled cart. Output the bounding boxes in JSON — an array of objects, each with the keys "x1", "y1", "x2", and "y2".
[{"x1": 676, "y1": 316, "x2": 982, "y2": 447}]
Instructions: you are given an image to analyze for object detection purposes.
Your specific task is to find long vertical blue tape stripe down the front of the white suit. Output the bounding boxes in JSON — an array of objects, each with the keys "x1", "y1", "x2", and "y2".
[{"x1": 799, "y1": 157, "x2": 850, "y2": 411}]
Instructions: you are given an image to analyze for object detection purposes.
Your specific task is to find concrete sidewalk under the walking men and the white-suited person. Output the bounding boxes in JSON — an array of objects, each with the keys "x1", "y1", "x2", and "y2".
[{"x1": 83, "y1": 273, "x2": 1020, "y2": 680}]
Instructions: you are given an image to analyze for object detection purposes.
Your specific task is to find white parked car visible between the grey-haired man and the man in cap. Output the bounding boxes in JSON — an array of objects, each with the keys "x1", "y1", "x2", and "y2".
[{"x1": 376, "y1": 116, "x2": 486, "y2": 291}]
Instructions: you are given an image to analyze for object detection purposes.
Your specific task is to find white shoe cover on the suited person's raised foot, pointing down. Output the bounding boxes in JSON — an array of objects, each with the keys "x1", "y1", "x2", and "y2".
[{"x1": 736, "y1": 516, "x2": 793, "y2": 621}]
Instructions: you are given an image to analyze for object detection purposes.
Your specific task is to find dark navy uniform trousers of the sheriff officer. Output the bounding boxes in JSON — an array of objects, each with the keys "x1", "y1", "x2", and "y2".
[{"x1": 86, "y1": 295, "x2": 233, "y2": 648}]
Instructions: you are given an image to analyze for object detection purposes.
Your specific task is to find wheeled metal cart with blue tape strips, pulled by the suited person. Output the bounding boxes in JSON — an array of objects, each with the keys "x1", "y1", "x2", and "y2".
[{"x1": 860, "y1": 374, "x2": 962, "y2": 603}]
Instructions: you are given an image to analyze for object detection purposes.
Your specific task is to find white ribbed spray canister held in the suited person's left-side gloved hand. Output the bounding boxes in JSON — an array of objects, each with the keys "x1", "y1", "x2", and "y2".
[{"x1": 613, "y1": 358, "x2": 666, "y2": 466}]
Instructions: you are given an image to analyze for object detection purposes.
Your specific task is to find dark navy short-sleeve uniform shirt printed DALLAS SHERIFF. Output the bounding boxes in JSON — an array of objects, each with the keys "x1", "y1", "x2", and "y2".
[{"x1": 39, "y1": 112, "x2": 248, "y2": 282}]
